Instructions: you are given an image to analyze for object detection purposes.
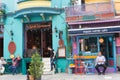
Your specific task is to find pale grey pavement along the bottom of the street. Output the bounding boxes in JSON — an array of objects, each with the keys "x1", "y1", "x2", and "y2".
[{"x1": 0, "y1": 73, "x2": 120, "y2": 80}]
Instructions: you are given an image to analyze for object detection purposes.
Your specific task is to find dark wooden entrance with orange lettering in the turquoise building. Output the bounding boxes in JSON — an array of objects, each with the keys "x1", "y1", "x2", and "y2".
[{"x1": 25, "y1": 22, "x2": 52, "y2": 57}]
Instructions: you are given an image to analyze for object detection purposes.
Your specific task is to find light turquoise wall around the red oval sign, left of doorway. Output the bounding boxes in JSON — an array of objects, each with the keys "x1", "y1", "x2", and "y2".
[{"x1": 4, "y1": 17, "x2": 23, "y2": 59}]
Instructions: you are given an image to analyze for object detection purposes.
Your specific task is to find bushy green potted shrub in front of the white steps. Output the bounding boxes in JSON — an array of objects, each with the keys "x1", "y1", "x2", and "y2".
[{"x1": 28, "y1": 52, "x2": 44, "y2": 80}]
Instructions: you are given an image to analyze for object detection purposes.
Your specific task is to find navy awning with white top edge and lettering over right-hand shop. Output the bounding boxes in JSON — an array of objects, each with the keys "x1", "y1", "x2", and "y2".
[{"x1": 68, "y1": 26, "x2": 120, "y2": 36}]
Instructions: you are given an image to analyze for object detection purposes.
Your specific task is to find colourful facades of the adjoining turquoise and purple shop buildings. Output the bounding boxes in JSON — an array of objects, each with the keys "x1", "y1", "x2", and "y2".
[{"x1": 0, "y1": 0, "x2": 120, "y2": 74}]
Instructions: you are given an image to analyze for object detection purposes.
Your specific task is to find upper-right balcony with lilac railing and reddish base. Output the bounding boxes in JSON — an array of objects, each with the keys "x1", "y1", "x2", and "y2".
[{"x1": 65, "y1": 2, "x2": 115, "y2": 22}]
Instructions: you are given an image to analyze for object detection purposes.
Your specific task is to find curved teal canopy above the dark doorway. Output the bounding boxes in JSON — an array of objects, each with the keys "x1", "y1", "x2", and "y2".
[{"x1": 13, "y1": 7, "x2": 63, "y2": 18}]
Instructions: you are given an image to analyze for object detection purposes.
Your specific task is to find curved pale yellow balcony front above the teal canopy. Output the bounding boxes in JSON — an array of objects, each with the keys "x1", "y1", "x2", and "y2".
[{"x1": 17, "y1": 0, "x2": 51, "y2": 10}]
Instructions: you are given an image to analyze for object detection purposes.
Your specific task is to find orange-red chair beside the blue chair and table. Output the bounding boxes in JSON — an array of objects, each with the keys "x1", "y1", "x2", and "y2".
[{"x1": 74, "y1": 59, "x2": 84, "y2": 74}]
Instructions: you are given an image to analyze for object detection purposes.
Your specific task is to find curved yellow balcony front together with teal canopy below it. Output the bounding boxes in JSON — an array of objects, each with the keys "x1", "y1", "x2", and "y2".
[{"x1": 13, "y1": 0, "x2": 63, "y2": 18}]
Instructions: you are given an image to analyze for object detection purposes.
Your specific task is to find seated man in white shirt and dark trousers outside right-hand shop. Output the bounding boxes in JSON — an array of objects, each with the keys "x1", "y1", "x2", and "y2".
[{"x1": 95, "y1": 52, "x2": 107, "y2": 75}]
